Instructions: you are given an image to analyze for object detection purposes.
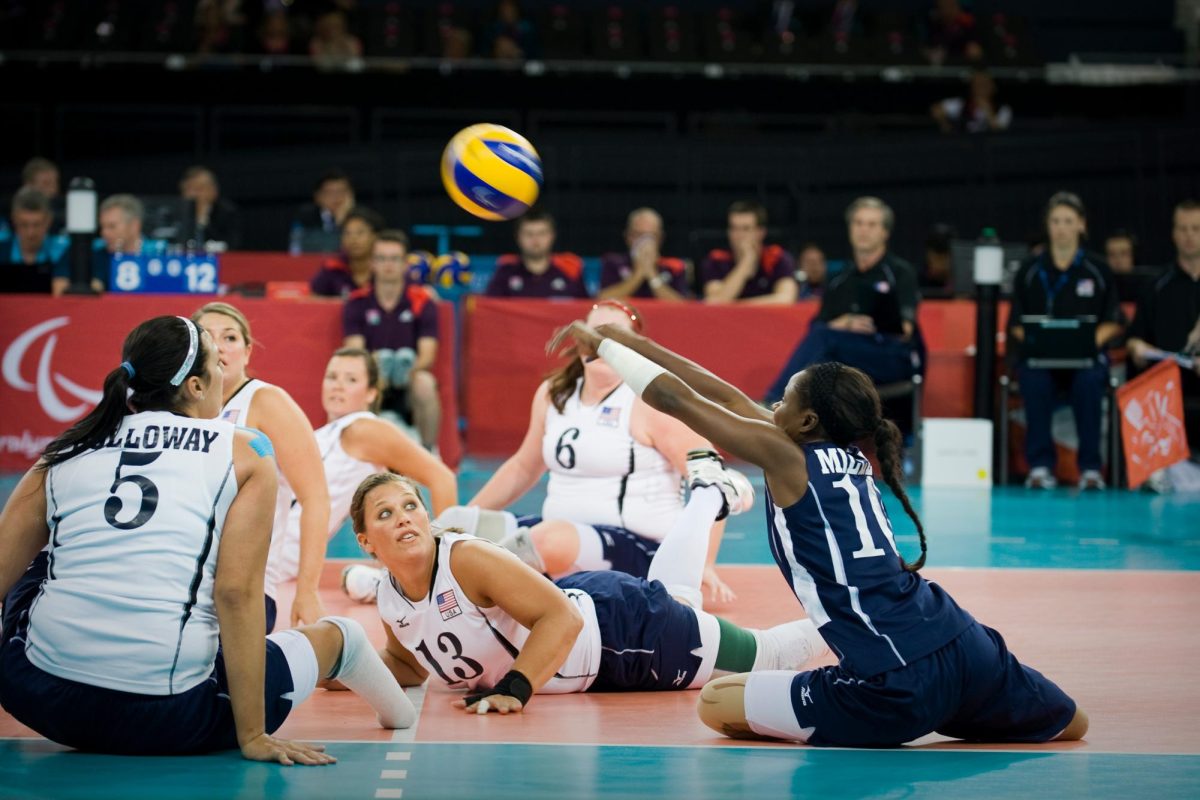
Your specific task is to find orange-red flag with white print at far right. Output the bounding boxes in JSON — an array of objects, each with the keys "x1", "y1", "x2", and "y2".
[{"x1": 1117, "y1": 361, "x2": 1188, "y2": 489}]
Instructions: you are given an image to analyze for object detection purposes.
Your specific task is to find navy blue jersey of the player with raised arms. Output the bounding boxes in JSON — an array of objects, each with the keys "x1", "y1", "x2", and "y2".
[{"x1": 767, "y1": 443, "x2": 974, "y2": 676}]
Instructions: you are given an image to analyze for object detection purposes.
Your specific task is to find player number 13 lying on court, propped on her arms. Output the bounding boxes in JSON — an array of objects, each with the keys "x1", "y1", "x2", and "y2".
[{"x1": 350, "y1": 465, "x2": 828, "y2": 714}]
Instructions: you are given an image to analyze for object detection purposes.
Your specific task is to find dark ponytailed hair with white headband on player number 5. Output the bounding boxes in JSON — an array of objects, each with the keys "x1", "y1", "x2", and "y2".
[{"x1": 37, "y1": 317, "x2": 208, "y2": 469}]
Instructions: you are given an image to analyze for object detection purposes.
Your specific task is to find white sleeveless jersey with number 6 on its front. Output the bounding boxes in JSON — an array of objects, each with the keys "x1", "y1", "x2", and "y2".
[{"x1": 541, "y1": 379, "x2": 683, "y2": 541}]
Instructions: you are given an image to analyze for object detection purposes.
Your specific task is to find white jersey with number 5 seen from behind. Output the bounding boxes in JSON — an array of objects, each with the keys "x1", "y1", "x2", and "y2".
[{"x1": 25, "y1": 411, "x2": 238, "y2": 694}]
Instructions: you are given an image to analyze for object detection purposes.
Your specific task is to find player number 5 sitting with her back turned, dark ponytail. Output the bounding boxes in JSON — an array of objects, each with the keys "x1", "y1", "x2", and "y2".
[{"x1": 0, "y1": 317, "x2": 415, "y2": 764}]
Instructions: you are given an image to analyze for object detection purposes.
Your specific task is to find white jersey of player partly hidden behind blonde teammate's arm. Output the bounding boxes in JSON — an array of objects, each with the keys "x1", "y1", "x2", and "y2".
[{"x1": 266, "y1": 411, "x2": 388, "y2": 584}]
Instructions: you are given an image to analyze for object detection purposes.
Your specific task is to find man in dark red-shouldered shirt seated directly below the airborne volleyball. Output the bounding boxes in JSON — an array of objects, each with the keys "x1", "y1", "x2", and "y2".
[{"x1": 484, "y1": 210, "x2": 588, "y2": 297}]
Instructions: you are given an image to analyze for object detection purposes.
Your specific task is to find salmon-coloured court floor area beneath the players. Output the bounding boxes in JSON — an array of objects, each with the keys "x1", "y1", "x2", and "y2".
[{"x1": 0, "y1": 563, "x2": 1200, "y2": 754}]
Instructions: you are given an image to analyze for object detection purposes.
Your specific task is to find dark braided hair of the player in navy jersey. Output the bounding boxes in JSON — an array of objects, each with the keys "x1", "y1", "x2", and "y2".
[{"x1": 797, "y1": 361, "x2": 926, "y2": 572}]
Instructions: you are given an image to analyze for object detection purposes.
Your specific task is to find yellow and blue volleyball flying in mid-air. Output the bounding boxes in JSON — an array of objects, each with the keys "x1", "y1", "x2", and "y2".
[{"x1": 442, "y1": 122, "x2": 541, "y2": 221}]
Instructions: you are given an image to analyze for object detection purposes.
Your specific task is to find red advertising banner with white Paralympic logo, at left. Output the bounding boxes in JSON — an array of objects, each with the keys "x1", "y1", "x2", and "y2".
[{"x1": 0, "y1": 295, "x2": 462, "y2": 471}]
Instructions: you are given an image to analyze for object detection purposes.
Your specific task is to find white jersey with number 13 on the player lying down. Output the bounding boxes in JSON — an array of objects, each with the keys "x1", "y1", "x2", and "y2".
[{"x1": 378, "y1": 533, "x2": 600, "y2": 694}]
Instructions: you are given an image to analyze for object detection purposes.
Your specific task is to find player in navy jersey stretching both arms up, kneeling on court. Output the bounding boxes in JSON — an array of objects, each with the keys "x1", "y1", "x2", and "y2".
[{"x1": 548, "y1": 323, "x2": 1087, "y2": 747}]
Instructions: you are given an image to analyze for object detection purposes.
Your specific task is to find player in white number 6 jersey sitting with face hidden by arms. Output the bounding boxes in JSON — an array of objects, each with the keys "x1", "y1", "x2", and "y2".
[{"x1": 438, "y1": 300, "x2": 745, "y2": 602}]
